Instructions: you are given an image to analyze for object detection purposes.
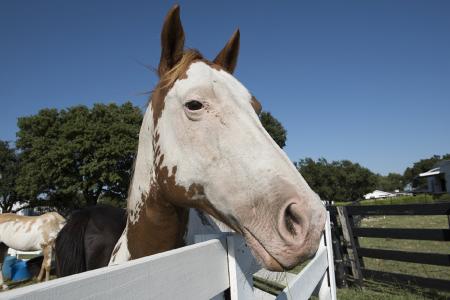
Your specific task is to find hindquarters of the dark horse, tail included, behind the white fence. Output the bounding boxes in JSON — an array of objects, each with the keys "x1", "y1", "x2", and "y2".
[{"x1": 55, "y1": 206, "x2": 126, "y2": 277}]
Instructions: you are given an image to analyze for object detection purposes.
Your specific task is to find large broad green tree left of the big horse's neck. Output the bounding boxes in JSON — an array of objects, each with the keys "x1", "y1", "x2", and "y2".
[{"x1": 16, "y1": 102, "x2": 142, "y2": 208}]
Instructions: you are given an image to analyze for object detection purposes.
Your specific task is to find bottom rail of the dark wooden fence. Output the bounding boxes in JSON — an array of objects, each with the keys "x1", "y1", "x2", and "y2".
[{"x1": 362, "y1": 269, "x2": 450, "y2": 291}]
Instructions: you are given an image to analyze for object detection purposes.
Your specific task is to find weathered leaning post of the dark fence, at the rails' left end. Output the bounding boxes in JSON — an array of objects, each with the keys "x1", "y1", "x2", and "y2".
[{"x1": 336, "y1": 206, "x2": 363, "y2": 285}]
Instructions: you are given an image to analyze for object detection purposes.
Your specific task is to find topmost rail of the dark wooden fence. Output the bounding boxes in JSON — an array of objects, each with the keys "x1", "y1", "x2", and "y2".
[{"x1": 346, "y1": 202, "x2": 450, "y2": 216}]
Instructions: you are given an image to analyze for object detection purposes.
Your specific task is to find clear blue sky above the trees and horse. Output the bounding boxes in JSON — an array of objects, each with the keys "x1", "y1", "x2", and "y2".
[{"x1": 0, "y1": 0, "x2": 450, "y2": 174}]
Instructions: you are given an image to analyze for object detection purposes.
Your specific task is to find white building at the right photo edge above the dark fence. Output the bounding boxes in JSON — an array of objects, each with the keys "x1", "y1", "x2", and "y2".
[{"x1": 418, "y1": 160, "x2": 450, "y2": 194}]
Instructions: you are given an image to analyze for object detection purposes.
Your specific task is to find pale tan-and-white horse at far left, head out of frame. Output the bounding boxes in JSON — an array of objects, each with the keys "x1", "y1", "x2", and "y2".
[{"x1": 0, "y1": 212, "x2": 65, "y2": 289}]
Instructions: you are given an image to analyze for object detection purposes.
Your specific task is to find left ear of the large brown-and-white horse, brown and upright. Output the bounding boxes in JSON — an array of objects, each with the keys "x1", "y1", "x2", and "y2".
[{"x1": 158, "y1": 5, "x2": 184, "y2": 77}]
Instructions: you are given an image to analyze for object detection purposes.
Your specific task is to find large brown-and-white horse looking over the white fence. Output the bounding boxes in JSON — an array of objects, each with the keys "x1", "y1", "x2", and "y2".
[{"x1": 110, "y1": 5, "x2": 325, "y2": 271}]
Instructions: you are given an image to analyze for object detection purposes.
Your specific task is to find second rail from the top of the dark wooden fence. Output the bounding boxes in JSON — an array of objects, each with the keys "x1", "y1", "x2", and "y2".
[{"x1": 353, "y1": 228, "x2": 450, "y2": 241}]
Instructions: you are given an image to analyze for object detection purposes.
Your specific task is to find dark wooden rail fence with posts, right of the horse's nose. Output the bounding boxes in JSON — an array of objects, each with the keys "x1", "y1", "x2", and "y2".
[{"x1": 328, "y1": 202, "x2": 450, "y2": 291}]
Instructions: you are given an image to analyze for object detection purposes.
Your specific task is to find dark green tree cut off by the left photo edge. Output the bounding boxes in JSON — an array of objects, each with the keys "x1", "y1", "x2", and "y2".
[{"x1": 0, "y1": 141, "x2": 21, "y2": 213}]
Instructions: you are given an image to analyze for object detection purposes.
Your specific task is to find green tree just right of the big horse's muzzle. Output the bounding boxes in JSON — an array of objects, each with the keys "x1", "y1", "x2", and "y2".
[{"x1": 295, "y1": 158, "x2": 377, "y2": 201}]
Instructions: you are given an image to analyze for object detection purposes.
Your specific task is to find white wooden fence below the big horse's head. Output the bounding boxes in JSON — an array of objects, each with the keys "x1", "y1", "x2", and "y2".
[{"x1": 0, "y1": 216, "x2": 336, "y2": 300}]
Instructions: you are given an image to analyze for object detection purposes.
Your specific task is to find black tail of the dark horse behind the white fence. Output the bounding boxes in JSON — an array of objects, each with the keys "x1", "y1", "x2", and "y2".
[{"x1": 55, "y1": 210, "x2": 90, "y2": 277}]
